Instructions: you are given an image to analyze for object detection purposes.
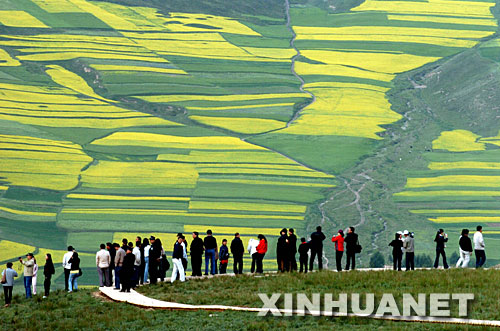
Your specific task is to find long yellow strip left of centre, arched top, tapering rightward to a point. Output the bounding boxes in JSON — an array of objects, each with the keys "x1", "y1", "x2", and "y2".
[{"x1": 92, "y1": 132, "x2": 265, "y2": 150}]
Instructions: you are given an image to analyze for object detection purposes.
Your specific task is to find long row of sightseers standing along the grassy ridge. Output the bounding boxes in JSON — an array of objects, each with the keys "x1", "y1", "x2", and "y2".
[{"x1": 1, "y1": 226, "x2": 486, "y2": 307}]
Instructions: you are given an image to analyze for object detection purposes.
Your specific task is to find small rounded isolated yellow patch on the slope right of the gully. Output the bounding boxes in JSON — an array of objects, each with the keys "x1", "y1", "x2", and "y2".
[{"x1": 432, "y1": 130, "x2": 486, "y2": 152}]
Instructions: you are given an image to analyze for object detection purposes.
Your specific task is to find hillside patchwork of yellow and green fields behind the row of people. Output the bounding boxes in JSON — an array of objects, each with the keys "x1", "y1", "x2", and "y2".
[{"x1": 0, "y1": 0, "x2": 500, "y2": 290}]
